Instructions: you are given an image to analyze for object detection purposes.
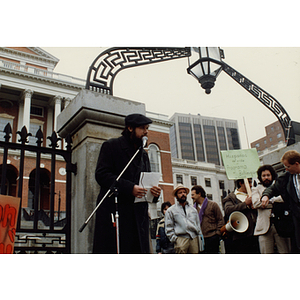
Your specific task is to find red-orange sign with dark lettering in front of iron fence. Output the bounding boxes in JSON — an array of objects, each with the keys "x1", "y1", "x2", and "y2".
[{"x1": 0, "y1": 195, "x2": 20, "y2": 254}]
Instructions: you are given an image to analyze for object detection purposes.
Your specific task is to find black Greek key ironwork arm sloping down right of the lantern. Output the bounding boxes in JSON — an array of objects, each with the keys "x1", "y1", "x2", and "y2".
[{"x1": 223, "y1": 62, "x2": 291, "y2": 137}]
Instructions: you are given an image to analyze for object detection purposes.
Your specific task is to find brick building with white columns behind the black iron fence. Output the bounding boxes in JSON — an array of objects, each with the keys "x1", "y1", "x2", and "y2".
[{"x1": 0, "y1": 47, "x2": 84, "y2": 217}]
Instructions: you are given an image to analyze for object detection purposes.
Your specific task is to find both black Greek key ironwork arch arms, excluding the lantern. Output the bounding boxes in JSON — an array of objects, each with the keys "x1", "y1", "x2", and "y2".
[{"x1": 86, "y1": 47, "x2": 295, "y2": 144}]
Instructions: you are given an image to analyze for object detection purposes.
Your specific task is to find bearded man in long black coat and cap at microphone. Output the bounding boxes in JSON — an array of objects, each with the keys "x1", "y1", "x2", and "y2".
[{"x1": 93, "y1": 114, "x2": 161, "y2": 254}]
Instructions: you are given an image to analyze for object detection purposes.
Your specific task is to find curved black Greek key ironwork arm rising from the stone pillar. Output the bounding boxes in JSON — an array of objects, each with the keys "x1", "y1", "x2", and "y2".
[{"x1": 86, "y1": 47, "x2": 191, "y2": 95}]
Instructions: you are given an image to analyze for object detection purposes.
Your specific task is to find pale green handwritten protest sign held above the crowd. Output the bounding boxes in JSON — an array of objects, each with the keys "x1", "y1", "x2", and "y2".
[{"x1": 221, "y1": 149, "x2": 261, "y2": 180}]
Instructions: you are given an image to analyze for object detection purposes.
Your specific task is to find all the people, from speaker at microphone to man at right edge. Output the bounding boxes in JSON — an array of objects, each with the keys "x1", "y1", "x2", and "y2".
[{"x1": 93, "y1": 114, "x2": 300, "y2": 254}]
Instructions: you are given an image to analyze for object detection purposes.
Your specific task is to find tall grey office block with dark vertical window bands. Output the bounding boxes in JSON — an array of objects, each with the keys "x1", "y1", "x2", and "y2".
[{"x1": 170, "y1": 113, "x2": 240, "y2": 165}]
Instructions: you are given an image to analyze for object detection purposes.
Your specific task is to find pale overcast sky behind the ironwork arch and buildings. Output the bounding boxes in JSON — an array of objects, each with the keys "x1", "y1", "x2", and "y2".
[{"x1": 42, "y1": 44, "x2": 300, "y2": 149}]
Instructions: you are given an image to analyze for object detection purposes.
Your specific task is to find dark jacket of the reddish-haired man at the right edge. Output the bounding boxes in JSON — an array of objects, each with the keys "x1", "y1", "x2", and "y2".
[{"x1": 262, "y1": 172, "x2": 300, "y2": 249}]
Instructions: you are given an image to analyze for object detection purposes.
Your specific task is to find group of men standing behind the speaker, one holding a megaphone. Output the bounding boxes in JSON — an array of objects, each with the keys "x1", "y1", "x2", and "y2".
[{"x1": 156, "y1": 150, "x2": 300, "y2": 254}]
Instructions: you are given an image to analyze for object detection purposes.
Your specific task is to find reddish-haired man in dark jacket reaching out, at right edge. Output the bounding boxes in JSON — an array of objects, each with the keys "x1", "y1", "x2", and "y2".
[{"x1": 261, "y1": 150, "x2": 300, "y2": 253}]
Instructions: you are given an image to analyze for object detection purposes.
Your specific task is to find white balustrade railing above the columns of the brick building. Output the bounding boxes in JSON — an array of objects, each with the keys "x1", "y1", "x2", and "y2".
[{"x1": 0, "y1": 60, "x2": 85, "y2": 87}]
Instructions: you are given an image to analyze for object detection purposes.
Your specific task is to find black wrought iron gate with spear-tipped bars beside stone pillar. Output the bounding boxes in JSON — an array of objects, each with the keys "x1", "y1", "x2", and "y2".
[{"x1": 0, "y1": 123, "x2": 76, "y2": 254}]
